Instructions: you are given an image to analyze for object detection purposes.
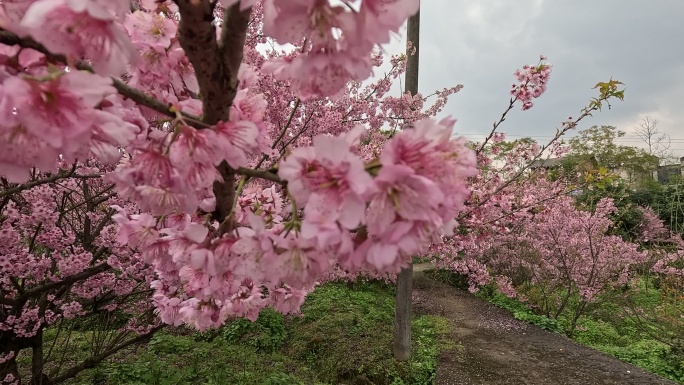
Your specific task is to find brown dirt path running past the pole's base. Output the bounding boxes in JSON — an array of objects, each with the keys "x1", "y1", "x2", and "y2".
[{"x1": 413, "y1": 265, "x2": 676, "y2": 385}]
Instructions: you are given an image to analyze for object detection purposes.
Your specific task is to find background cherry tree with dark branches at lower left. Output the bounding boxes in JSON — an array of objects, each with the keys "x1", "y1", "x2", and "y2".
[{"x1": 0, "y1": 164, "x2": 161, "y2": 384}]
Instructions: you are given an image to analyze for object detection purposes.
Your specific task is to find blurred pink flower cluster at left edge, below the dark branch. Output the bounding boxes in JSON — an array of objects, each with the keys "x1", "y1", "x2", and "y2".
[{"x1": 0, "y1": 64, "x2": 137, "y2": 182}]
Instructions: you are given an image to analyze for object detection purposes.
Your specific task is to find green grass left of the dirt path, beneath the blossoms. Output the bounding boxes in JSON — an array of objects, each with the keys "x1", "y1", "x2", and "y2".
[{"x1": 61, "y1": 282, "x2": 448, "y2": 385}]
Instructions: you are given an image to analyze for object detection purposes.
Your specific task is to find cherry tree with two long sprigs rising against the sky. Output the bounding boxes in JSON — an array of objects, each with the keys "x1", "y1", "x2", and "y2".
[{"x1": 426, "y1": 78, "x2": 624, "y2": 284}]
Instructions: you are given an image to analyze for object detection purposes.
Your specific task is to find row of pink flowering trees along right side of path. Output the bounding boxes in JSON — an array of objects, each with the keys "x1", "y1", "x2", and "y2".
[{"x1": 444, "y1": 146, "x2": 684, "y2": 340}]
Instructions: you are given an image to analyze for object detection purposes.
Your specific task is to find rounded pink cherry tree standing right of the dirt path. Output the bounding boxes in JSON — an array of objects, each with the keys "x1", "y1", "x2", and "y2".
[{"x1": 487, "y1": 197, "x2": 646, "y2": 336}]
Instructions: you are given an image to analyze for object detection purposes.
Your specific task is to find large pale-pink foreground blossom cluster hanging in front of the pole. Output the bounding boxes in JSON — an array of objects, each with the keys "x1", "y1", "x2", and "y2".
[{"x1": 114, "y1": 115, "x2": 476, "y2": 328}]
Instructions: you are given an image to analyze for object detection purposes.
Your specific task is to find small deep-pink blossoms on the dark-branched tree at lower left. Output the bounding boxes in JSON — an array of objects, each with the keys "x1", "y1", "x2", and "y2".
[{"x1": 0, "y1": 173, "x2": 156, "y2": 338}]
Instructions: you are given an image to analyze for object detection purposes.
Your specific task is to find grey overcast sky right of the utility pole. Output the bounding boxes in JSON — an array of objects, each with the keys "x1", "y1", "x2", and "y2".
[{"x1": 376, "y1": 0, "x2": 684, "y2": 156}]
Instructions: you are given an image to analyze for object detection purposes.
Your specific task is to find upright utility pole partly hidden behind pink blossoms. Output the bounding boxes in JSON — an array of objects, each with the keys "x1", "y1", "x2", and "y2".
[{"x1": 393, "y1": 8, "x2": 420, "y2": 361}]
